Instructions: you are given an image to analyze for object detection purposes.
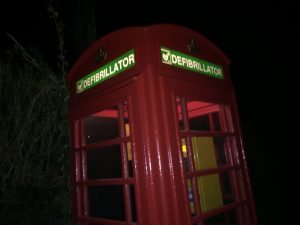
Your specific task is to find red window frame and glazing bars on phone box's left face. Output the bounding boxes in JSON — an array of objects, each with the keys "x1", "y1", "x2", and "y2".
[{"x1": 71, "y1": 87, "x2": 137, "y2": 225}]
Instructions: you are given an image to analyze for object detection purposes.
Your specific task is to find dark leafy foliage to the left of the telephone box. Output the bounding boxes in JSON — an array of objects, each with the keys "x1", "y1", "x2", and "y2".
[{"x1": 0, "y1": 25, "x2": 70, "y2": 225}]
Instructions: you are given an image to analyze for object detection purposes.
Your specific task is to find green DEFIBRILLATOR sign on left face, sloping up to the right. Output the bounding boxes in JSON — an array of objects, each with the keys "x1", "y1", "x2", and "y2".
[{"x1": 76, "y1": 49, "x2": 135, "y2": 94}]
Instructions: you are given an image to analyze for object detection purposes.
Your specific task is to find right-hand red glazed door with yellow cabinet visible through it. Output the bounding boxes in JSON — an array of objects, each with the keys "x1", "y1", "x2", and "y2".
[{"x1": 159, "y1": 78, "x2": 255, "y2": 225}]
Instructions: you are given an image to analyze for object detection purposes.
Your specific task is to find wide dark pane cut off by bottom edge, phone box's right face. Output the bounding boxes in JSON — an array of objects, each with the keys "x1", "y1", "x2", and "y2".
[{"x1": 204, "y1": 210, "x2": 239, "y2": 225}]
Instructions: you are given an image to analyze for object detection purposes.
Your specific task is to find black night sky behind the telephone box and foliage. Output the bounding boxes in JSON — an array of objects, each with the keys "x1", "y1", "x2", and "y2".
[{"x1": 0, "y1": 0, "x2": 300, "y2": 225}]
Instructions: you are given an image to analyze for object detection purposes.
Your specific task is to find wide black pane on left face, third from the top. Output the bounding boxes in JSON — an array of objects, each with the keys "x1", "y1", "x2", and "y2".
[{"x1": 88, "y1": 185, "x2": 125, "y2": 220}]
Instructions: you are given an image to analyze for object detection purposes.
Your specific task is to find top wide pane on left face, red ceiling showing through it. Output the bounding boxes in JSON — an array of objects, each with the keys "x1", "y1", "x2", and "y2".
[{"x1": 83, "y1": 107, "x2": 119, "y2": 144}]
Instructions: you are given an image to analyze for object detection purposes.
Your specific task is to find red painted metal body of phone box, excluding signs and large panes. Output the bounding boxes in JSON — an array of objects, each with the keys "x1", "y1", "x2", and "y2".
[{"x1": 68, "y1": 25, "x2": 257, "y2": 225}]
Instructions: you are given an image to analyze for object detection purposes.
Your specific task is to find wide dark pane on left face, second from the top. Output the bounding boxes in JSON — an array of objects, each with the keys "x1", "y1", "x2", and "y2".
[{"x1": 87, "y1": 145, "x2": 122, "y2": 179}]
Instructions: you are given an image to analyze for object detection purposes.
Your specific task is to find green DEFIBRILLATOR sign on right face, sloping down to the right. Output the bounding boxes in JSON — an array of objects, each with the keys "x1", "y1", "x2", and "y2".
[{"x1": 160, "y1": 47, "x2": 224, "y2": 79}]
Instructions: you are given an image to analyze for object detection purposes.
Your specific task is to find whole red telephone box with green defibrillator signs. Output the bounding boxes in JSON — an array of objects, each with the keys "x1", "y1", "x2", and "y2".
[{"x1": 68, "y1": 25, "x2": 257, "y2": 225}]
